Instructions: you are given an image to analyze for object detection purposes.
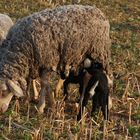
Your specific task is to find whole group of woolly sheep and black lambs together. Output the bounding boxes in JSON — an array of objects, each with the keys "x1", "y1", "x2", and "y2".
[{"x1": 0, "y1": 5, "x2": 112, "y2": 120}]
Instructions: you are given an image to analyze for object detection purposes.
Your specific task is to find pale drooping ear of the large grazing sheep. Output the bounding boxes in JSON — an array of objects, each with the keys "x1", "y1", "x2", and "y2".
[{"x1": 7, "y1": 80, "x2": 24, "y2": 97}]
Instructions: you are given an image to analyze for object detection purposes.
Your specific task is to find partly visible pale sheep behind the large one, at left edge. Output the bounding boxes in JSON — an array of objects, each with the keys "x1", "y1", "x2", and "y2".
[{"x1": 0, "y1": 14, "x2": 13, "y2": 45}]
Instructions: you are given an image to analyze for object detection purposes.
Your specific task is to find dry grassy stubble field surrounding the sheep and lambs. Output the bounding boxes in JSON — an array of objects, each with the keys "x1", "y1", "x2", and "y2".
[{"x1": 0, "y1": 0, "x2": 140, "y2": 140}]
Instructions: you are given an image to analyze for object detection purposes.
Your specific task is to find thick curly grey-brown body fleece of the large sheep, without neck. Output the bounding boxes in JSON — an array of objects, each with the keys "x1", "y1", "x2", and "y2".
[{"x1": 1, "y1": 5, "x2": 110, "y2": 79}]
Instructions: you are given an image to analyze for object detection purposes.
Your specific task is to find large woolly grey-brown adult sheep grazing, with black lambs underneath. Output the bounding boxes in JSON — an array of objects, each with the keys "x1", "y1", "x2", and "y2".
[{"x1": 0, "y1": 5, "x2": 111, "y2": 113}]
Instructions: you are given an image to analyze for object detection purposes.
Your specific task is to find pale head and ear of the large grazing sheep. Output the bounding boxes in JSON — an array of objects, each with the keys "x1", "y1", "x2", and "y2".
[{"x1": 0, "y1": 79, "x2": 23, "y2": 112}]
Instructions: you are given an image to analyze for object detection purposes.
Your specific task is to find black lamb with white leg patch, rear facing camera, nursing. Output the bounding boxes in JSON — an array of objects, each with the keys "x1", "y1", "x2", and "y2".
[{"x1": 77, "y1": 63, "x2": 111, "y2": 121}]
